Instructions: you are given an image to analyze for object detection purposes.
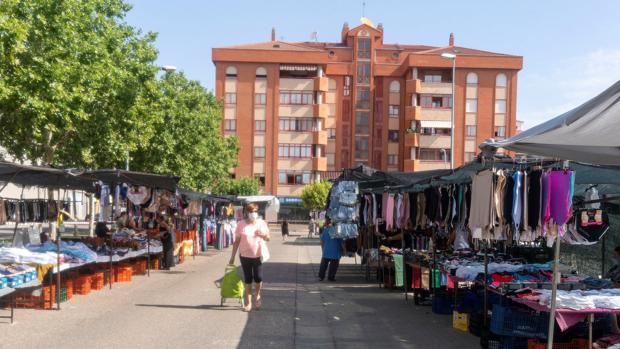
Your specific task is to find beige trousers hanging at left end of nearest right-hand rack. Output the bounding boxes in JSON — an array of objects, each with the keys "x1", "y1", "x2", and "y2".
[{"x1": 469, "y1": 170, "x2": 493, "y2": 239}]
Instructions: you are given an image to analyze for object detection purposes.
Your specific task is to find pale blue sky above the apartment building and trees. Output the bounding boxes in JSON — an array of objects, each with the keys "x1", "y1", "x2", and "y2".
[{"x1": 127, "y1": 0, "x2": 620, "y2": 127}]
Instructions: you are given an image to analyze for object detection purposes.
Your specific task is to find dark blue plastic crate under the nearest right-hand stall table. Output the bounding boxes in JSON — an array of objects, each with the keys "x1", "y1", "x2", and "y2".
[{"x1": 490, "y1": 304, "x2": 549, "y2": 339}]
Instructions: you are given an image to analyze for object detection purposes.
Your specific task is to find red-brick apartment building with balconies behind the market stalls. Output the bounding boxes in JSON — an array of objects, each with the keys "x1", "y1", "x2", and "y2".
[{"x1": 213, "y1": 23, "x2": 523, "y2": 197}]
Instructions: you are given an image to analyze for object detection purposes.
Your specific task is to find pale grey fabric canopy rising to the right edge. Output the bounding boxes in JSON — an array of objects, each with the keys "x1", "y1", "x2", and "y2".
[{"x1": 480, "y1": 81, "x2": 620, "y2": 165}]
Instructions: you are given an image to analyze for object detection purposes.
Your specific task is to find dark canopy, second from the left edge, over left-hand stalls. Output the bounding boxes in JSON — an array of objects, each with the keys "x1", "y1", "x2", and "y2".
[{"x1": 82, "y1": 170, "x2": 180, "y2": 192}]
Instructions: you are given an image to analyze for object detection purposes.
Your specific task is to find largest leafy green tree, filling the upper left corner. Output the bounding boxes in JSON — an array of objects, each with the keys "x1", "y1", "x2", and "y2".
[{"x1": 0, "y1": 0, "x2": 157, "y2": 168}]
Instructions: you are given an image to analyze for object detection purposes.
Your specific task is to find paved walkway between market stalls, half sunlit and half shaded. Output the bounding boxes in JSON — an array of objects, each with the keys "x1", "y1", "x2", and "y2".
[{"x1": 0, "y1": 228, "x2": 479, "y2": 349}]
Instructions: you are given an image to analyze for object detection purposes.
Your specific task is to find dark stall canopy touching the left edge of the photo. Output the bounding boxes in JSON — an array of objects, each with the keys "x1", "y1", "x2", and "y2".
[{"x1": 0, "y1": 161, "x2": 95, "y2": 192}]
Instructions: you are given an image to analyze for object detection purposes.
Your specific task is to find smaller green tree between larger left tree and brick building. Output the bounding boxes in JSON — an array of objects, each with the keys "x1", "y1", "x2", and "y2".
[{"x1": 131, "y1": 73, "x2": 239, "y2": 191}]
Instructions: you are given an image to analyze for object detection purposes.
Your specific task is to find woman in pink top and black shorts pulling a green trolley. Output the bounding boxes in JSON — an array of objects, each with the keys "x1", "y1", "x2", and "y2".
[{"x1": 229, "y1": 203, "x2": 271, "y2": 311}]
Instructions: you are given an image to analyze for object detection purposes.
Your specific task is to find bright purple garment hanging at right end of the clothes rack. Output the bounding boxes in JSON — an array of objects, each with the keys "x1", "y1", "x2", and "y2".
[{"x1": 549, "y1": 171, "x2": 573, "y2": 236}]
